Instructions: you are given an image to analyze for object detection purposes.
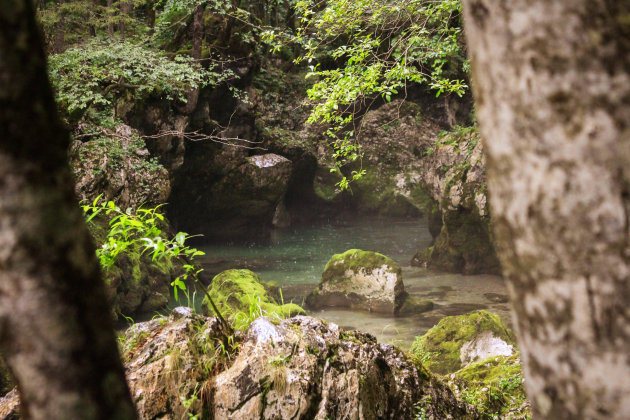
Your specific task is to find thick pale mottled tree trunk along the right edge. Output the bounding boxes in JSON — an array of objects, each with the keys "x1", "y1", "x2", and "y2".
[{"x1": 465, "y1": 0, "x2": 630, "y2": 419}]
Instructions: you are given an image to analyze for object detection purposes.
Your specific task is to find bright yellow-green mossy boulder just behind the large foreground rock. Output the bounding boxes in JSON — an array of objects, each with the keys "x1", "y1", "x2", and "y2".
[{"x1": 202, "y1": 269, "x2": 305, "y2": 328}]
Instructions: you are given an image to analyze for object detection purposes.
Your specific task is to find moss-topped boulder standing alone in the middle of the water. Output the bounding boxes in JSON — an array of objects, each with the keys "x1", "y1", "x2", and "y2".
[{"x1": 306, "y1": 249, "x2": 406, "y2": 314}]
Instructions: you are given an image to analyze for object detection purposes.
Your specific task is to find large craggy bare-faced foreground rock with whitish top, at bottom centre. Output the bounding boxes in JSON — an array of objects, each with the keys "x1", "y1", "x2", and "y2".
[{"x1": 211, "y1": 316, "x2": 478, "y2": 419}]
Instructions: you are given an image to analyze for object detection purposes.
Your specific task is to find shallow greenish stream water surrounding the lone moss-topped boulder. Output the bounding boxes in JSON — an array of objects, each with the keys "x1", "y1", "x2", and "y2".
[{"x1": 199, "y1": 218, "x2": 510, "y2": 349}]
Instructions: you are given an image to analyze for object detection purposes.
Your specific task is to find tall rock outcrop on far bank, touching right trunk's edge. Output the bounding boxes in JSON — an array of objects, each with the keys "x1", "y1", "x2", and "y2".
[{"x1": 411, "y1": 127, "x2": 500, "y2": 274}]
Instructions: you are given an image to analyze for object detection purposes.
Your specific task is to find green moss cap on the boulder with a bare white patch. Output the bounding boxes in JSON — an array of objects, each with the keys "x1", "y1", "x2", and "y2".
[{"x1": 411, "y1": 310, "x2": 514, "y2": 374}]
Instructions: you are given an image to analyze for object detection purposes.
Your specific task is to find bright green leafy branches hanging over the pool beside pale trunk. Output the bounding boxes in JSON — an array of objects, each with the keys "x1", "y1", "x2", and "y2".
[{"x1": 265, "y1": 0, "x2": 468, "y2": 187}]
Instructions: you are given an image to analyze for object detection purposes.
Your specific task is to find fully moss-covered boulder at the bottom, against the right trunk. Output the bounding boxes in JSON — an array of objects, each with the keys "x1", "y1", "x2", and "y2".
[{"x1": 448, "y1": 354, "x2": 531, "y2": 420}]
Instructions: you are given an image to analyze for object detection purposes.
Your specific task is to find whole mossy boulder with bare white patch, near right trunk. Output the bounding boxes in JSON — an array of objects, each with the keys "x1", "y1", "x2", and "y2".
[{"x1": 411, "y1": 310, "x2": 515, "y2": 374}]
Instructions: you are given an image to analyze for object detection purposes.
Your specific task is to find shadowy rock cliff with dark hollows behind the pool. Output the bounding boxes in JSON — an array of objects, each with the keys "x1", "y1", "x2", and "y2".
[{"x1": 74, "y1": 56, "x2": 499, "y2": 273}]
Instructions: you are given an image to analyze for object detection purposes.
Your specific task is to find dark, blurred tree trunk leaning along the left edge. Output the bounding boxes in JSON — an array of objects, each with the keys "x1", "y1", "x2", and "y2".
[{"x1": 0, "y1": 0, "x2": 135, "y2": 420}]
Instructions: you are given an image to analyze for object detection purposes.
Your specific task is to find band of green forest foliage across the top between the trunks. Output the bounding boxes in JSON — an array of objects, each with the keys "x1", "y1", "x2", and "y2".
[{"x1": 39, "y1": 0, "x2": 468, "y2": 187}]
